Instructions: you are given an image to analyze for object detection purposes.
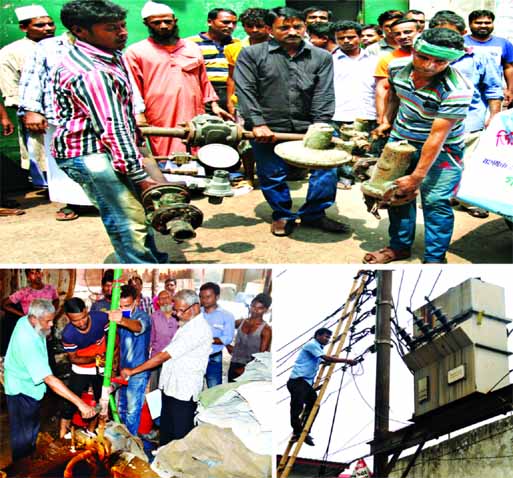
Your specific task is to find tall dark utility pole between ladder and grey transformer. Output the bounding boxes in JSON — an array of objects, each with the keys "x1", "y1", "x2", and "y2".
[{"x1": 374, "y1": 270, "x2": 392, "y2": 478}]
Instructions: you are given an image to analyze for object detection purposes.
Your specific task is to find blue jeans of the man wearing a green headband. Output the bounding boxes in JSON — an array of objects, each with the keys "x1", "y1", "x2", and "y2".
[{"x1": 388, "y1": 143, "x2": 463, "y2": 263}]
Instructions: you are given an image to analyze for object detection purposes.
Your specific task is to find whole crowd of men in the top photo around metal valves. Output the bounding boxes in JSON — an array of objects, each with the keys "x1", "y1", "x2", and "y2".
[{"x1": 0, "y1": 0, "x2": 513, "y2": 263}]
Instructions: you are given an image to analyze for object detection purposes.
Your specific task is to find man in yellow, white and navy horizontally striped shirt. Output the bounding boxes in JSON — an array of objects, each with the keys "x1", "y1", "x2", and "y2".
[{"x1": 188, "y1": 8, "x2": 239, "y2": 110}]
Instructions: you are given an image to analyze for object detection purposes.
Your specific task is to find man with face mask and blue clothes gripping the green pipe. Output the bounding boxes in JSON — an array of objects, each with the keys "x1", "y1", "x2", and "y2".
[{"x1": 109, "y1": 285, "x2": 151, "y2": 435}]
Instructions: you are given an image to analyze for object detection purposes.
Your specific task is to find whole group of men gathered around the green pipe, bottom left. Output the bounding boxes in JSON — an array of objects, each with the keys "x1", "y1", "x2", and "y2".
[{"x1": 3, "y1": 269, "x2": 271, "y2": 460}]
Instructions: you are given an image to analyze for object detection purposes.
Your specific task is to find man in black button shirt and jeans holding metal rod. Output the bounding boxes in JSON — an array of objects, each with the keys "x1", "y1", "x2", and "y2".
[{"x1": 234, "y1": 7, "x2": 348, "y2": 236}]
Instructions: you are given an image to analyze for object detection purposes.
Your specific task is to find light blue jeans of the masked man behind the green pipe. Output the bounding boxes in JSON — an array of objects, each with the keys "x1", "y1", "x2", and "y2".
[{"x1": 118, "y1": 372, "x2": 149, "y2": 436}]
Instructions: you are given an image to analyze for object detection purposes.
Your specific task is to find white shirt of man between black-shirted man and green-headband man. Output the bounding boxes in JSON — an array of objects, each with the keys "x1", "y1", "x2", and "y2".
[{"x1": 333, "y1": 49, "x2": 378, "y2": 121}]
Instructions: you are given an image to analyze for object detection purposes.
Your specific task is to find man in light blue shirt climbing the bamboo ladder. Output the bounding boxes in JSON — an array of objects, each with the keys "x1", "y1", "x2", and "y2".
[{"x1": 287, "y1": 327, "x2": 356, "y2": 446}]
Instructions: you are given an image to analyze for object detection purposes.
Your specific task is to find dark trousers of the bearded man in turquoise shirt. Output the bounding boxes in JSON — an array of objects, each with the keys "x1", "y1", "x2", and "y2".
[{"x1": 6, "y1": 393, "x2": 41, "y2": 461}]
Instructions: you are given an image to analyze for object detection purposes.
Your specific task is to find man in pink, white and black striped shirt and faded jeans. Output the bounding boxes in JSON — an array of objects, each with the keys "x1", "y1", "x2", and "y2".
[{"x1": 53, "y1": 0, "x2": 167, "y2": 263}]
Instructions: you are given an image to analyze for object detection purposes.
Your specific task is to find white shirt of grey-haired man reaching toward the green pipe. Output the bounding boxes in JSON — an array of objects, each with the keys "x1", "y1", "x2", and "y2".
[{"x1": 159, "y1": 314, "x2": 213, "y2": 401}]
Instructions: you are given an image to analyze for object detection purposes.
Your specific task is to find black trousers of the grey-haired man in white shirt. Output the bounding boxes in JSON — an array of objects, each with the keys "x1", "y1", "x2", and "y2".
[{"x1": 160, "y1": 392, "x2": 198, "y2": 446}]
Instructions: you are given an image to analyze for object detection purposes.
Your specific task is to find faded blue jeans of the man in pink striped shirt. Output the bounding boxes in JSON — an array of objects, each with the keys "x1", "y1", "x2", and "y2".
[{"x1": 58, "y1": 153, "x2": 168, "y2": 264}]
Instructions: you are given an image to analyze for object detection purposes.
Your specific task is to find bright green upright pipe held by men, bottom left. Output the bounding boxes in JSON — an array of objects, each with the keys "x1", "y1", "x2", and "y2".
[{"x1": 98, "y1": 269, "x2": 123, "y2": 438}]
